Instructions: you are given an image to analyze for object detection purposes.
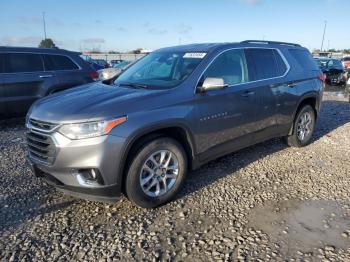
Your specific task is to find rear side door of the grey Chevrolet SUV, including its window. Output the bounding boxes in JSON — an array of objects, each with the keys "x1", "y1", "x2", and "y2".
[{"x1": 245, "y1": 48, "x2": 295, "y2": 137}]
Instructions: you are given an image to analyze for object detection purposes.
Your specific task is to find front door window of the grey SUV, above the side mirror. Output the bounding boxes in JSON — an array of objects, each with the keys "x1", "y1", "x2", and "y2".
[{"x1": 202, "y1": 49, "x2": 248, "y2": 85}]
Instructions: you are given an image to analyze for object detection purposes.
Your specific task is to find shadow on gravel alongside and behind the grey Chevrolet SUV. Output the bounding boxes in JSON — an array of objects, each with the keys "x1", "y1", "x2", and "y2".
[{"x1": 177, "y1": 100, "x2": 350, "y2": 199}]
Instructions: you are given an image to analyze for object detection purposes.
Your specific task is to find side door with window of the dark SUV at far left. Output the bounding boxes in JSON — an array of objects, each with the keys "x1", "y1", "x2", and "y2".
[{"x1": 3, "y1": 53, "x2": 57, "y2": 116}]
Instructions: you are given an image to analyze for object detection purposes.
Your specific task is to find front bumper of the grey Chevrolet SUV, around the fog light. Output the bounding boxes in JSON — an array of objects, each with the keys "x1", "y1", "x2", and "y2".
[{"x1": 27, "y1": 133, "x2": 125, "y2": 202}]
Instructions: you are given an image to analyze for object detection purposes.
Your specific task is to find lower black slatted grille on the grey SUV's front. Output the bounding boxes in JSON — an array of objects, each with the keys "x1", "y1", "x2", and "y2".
[{"x1": 27, "y1": 130, "x2": 56, "y2": 164}]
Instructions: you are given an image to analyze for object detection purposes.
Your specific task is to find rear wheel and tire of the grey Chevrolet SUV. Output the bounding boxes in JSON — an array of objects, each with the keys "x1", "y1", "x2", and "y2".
[{"x1": 285, "y1": 105, "x2": 316, "y2": 147}]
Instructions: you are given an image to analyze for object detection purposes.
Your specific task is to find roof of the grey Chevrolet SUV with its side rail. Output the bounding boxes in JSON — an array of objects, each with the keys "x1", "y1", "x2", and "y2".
[{"x1": 155, "y1": 40, "x2": 301, "y2": 52}]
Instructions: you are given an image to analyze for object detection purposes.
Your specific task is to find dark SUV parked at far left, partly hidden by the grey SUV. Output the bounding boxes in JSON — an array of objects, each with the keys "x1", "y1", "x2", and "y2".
[{"x1": 0, "y1": 47, "x2": 98, "y2": 117}]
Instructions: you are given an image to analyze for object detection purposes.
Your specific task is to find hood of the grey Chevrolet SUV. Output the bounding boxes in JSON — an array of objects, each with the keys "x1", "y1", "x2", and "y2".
[{"x1": 28, "y1": 83, "x2": 162, "y2": 123}]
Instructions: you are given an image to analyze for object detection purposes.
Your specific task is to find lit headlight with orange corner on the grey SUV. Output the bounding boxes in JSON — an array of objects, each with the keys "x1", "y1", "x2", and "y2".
[{"x1": 59, "y1": 116, "x2": 126, "y2": 139}]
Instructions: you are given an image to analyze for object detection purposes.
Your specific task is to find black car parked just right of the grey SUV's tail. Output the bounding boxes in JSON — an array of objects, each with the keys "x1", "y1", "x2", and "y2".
[{"x1": 315, "y1": 58, "x2": 348, "y2": 86}]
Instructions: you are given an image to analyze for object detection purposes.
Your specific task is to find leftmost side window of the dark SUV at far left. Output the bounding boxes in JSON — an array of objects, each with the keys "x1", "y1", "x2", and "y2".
[{"x1": 5, "y1": 53, "x2": 44, "y2": 73}]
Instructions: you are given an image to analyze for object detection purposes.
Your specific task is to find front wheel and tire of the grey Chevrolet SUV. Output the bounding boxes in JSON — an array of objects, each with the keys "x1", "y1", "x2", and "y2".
[{"x1": 125, "y1": 137, "x2": 187, "y2": 208}]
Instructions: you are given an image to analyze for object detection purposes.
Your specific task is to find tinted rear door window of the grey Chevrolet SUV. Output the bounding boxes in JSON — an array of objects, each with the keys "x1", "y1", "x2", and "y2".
[{"x1": 245, "y1": 48, "x2": 286, "y2": 80}]
